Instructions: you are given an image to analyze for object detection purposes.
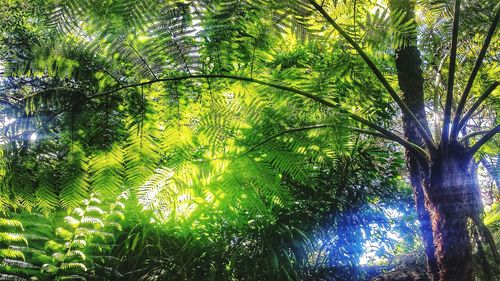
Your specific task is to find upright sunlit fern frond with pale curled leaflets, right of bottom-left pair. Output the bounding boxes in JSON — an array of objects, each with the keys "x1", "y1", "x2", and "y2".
[{"x1": 43, "y1": 192, "x2": 127, "y2": 280}]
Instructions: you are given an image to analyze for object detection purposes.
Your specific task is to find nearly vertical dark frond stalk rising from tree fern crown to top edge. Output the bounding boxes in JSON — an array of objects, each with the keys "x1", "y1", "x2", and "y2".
[{"x1": 440, "y1": 0, "x2": 461, "y2": 150}]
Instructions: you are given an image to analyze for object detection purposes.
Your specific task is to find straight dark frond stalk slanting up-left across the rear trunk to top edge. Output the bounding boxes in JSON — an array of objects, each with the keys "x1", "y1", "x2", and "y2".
[{"x1": 308, "y1": 0, "x2": 435, "y2": 148}]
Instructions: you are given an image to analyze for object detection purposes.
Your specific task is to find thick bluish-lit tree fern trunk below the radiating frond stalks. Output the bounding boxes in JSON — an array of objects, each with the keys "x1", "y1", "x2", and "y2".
[{"x1": 425, "y1": 144, "x2": 476, "y2": 281}]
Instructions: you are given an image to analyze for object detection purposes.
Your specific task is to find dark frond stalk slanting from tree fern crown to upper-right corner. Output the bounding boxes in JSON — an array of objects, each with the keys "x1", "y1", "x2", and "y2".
[{"x1": 451, "y1": 5, "x2": 500, "y2": 140}]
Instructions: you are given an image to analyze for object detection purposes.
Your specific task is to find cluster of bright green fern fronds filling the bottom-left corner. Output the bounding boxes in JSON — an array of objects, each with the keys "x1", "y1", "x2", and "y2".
[{"x1": 0, "y1": 193, "x2": 127, "y2": 280}]
